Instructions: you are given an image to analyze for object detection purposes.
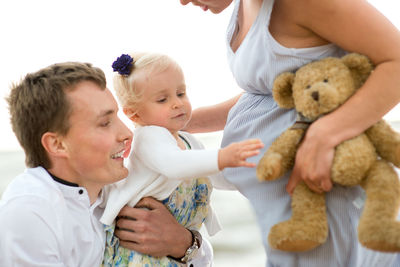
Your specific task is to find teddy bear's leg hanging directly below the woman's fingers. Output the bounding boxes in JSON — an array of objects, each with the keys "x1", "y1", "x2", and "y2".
[{"x1": 268, "y1": 183, "x2": 328, "y2": 252}]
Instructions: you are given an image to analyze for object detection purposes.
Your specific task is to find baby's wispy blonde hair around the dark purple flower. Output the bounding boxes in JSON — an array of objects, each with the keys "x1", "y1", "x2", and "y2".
[{"x1": 113, "y1": 52, "x2": 180, "y2": 117}]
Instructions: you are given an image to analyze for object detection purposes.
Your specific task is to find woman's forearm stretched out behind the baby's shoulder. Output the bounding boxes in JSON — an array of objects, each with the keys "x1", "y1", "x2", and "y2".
[{"x1": 184, "y1": 94, "x2": 242, "y2": 133}]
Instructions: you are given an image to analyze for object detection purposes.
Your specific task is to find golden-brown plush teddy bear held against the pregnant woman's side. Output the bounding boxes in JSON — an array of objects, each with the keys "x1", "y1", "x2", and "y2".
[{"x1": 257, "y1": 53, "x2": 400, "y2": 252}]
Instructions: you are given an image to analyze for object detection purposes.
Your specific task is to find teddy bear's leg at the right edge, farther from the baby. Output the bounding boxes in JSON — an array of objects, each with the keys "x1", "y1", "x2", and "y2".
[{"x1": 358, "y1": 160, "x2": 400, "y2": 252}]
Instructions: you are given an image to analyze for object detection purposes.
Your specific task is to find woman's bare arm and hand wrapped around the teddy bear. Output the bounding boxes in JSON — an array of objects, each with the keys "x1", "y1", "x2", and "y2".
[{"x1": 287, "y1": 0, "x2": 400, "y2": 193}]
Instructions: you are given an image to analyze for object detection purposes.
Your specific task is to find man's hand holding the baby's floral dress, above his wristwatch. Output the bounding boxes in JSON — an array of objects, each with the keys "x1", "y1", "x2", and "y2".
[{"x1": 115, "y1": 197, "x2": 192, "y2": 258}]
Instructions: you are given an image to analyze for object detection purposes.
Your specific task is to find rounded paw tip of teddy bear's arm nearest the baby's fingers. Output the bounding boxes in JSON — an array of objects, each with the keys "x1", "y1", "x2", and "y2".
[{"x1": 256, "y1": 152, "x2": 282, "y2": 181}]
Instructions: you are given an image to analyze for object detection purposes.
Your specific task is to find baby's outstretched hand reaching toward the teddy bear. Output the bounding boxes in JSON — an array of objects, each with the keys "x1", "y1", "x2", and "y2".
[{"x1": 218, "y1": 139, "x2": 264, "y2": 170}]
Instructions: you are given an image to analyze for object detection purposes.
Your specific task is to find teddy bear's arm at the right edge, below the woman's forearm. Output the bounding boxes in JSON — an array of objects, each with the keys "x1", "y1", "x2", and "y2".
[{"x1": 365, "y1": 120, "x2": 400, "y2": 167}]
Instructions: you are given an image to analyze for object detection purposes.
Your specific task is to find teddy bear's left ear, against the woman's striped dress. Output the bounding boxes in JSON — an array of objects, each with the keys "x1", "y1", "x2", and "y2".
[{"x1": 272, "y1": 72, "x2": 294, "y2": 108}]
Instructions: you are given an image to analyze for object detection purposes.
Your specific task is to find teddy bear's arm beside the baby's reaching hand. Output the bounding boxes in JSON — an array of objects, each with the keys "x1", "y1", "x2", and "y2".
[{"x1": 257, "y1": 128, "x2": 304, "y2": 181}]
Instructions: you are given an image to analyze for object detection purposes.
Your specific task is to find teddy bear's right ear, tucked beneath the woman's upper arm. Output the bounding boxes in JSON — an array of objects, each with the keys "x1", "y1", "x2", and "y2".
[{"x1": 342, "y1": 53, "x2": 374, "y2": 87}]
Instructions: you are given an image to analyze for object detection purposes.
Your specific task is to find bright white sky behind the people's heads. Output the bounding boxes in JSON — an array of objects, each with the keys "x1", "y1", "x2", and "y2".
[{"x1": 0, "y1": 0, "x2": 400, "y2": 151}]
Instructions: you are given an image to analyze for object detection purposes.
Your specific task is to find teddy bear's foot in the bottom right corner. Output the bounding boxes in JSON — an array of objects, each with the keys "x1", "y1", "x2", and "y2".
[{"x1": 358, "y1": 222, "x2": 400, "y2": 252}]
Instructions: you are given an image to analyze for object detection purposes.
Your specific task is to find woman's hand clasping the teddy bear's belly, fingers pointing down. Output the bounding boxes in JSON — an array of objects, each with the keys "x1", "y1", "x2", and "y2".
[{"x1": 286, "y1": 121, "x2": 335, "y2": 195}]
